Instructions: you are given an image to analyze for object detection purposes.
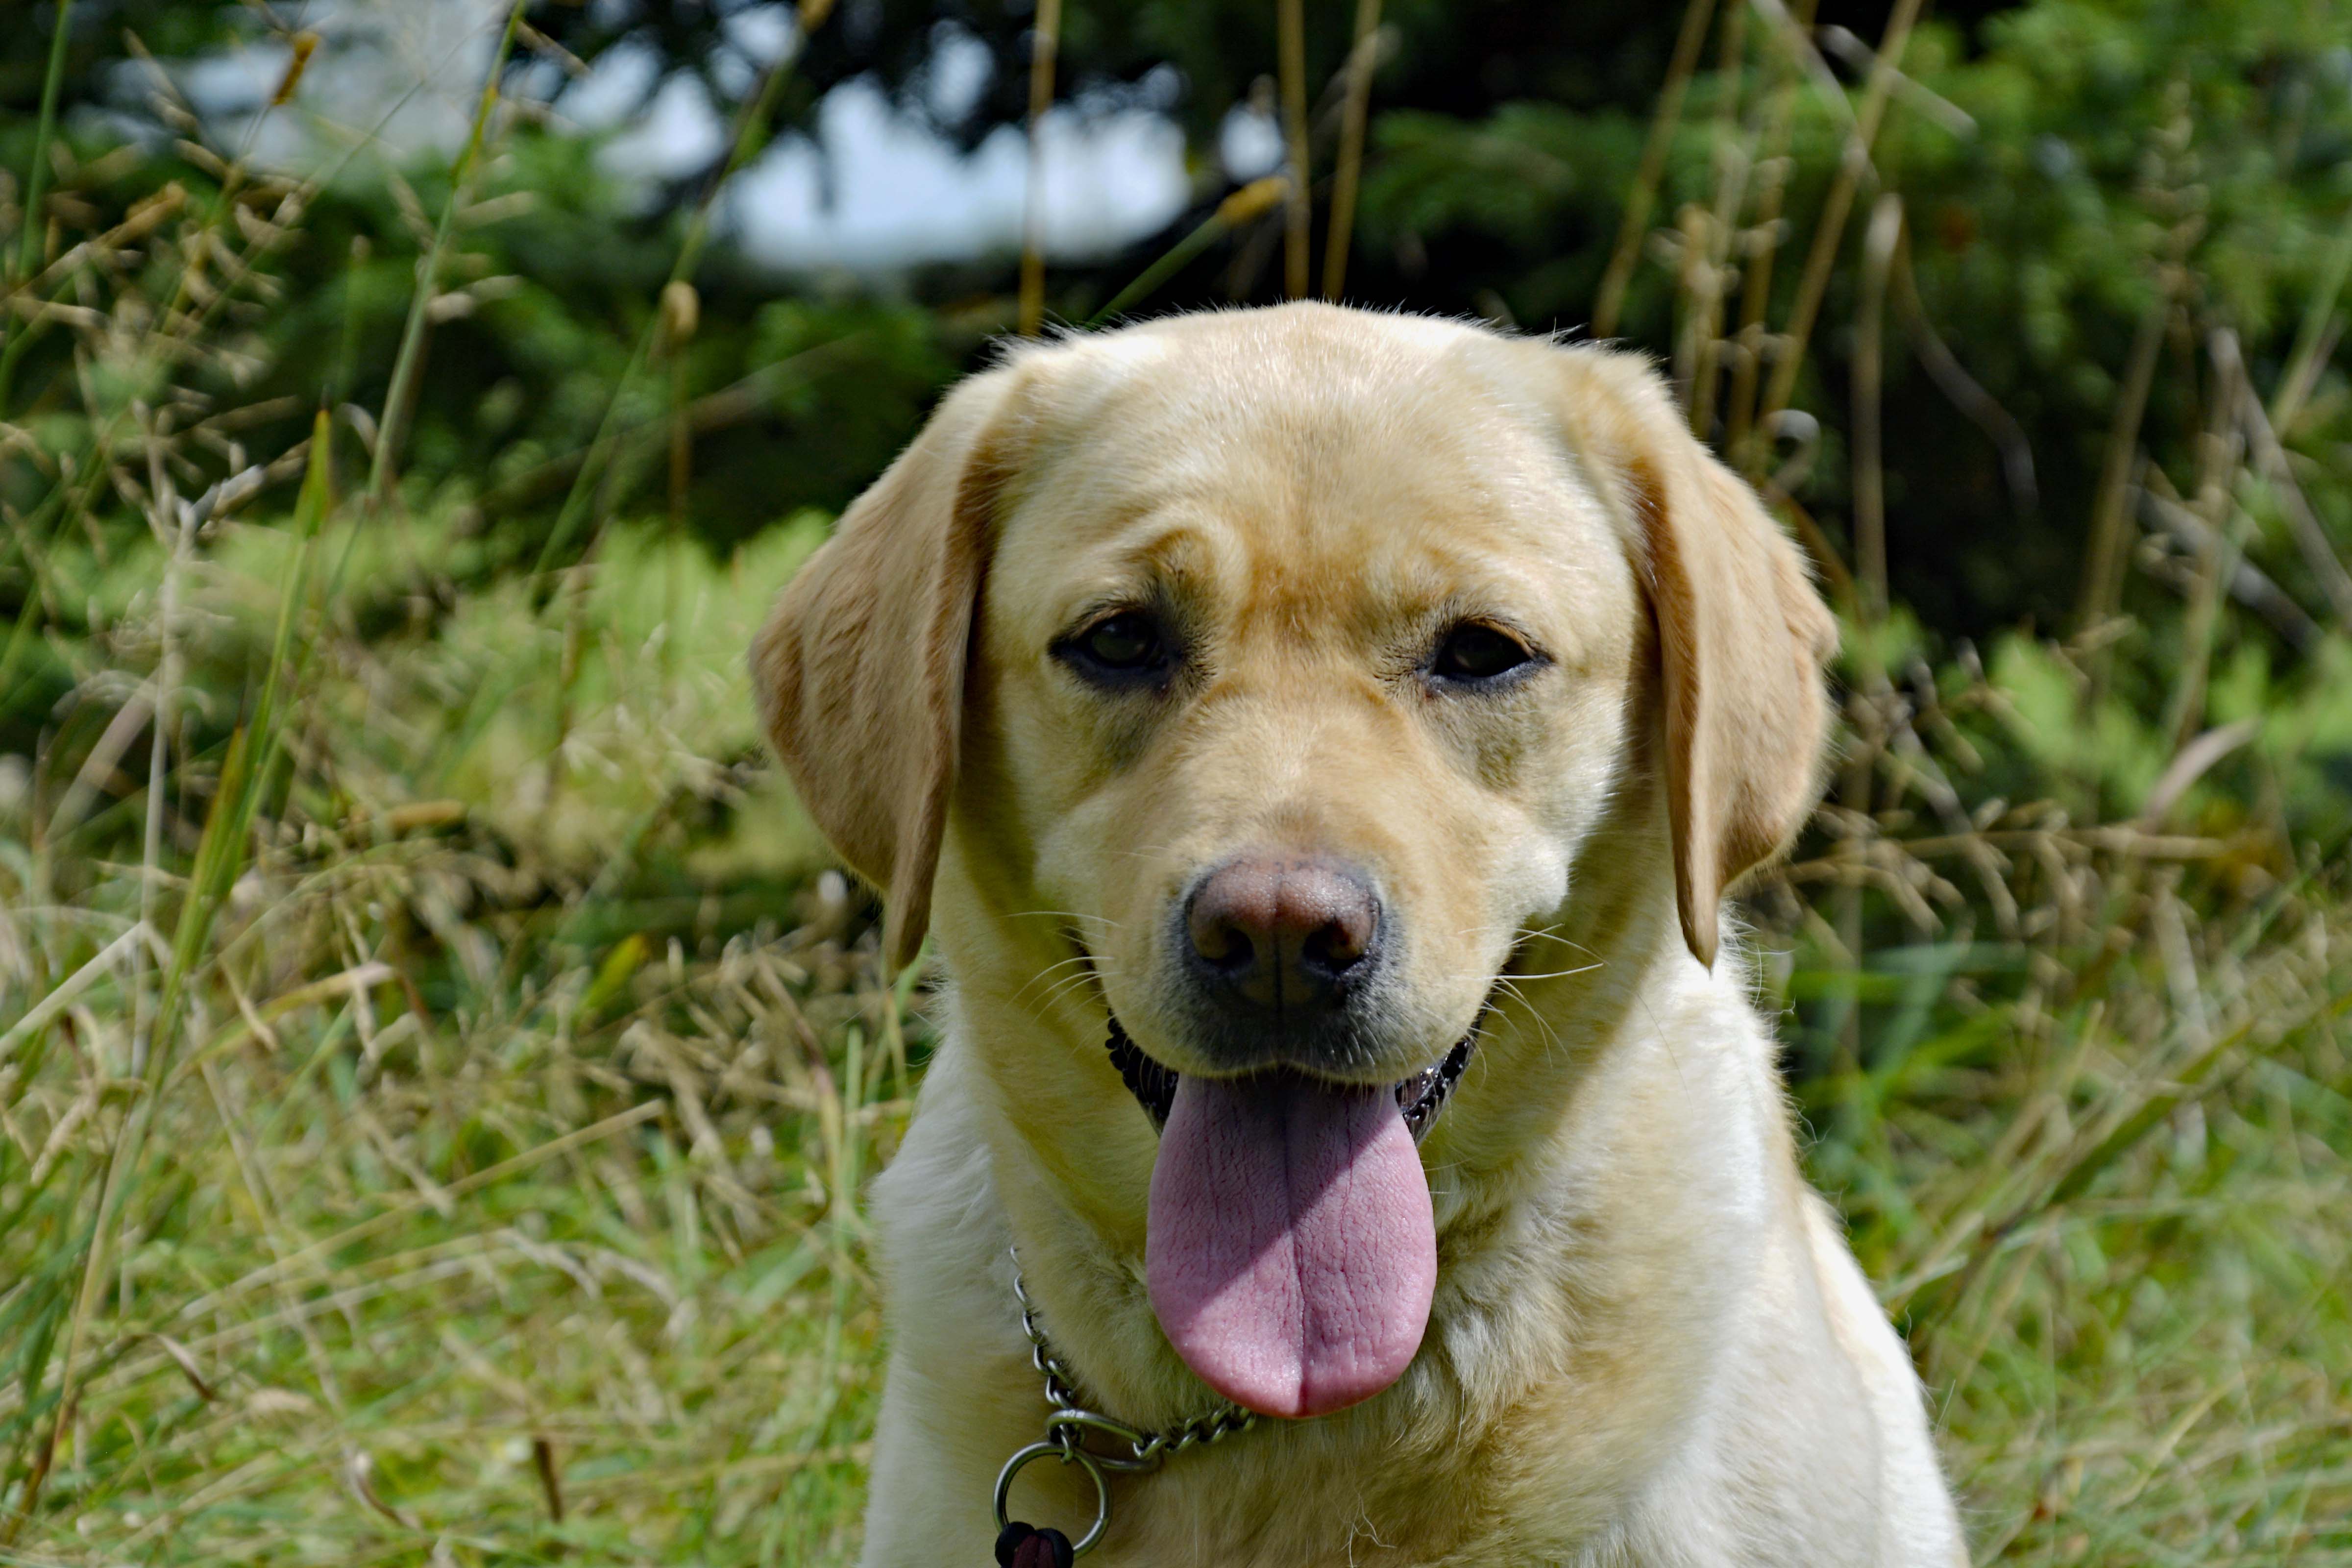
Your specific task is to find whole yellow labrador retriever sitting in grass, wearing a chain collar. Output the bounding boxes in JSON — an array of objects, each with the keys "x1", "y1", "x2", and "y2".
[{"x1": 753, "y1": 306, "x2": 1966, "y2": 1568}]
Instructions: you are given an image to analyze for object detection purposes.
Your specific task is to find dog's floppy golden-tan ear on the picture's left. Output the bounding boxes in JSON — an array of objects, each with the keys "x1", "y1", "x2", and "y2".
[{"x1": 750, "y1": 367, "x2": 1021, "y2": 969}]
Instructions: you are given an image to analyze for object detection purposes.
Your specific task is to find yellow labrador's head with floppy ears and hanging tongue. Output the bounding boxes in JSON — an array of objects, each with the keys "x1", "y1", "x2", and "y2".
[{"x1": 755, "y1": 306, "x2": 1835, "y2": 1415}]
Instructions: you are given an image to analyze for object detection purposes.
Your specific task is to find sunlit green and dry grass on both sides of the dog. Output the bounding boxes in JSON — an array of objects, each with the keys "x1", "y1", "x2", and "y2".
[{"x1": 0, "y1": 524, "x2": 2352, "y2": 1563}]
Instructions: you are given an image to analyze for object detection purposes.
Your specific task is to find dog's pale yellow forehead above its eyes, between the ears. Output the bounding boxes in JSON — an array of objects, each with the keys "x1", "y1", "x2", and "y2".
[{"x1": 988, "y1": 306, "x2": 1620, "y2": 602}]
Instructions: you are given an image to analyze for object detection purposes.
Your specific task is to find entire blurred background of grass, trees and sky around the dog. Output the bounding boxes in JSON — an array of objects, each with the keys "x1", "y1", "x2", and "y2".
[{"x1": 0, "y1": 0, "x2": 2352, "y2": 1566}]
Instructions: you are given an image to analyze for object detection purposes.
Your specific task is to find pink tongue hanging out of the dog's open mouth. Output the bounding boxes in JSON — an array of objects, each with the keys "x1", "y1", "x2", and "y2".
[{"x1": 1143, "y1": 1072, "x2": 1437, "y2": 1415}]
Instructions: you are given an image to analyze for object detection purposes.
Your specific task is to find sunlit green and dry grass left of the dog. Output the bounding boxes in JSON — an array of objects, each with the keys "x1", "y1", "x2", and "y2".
[{"x1": 0, "y1": 510, "x2": 889, "y2": 1563}]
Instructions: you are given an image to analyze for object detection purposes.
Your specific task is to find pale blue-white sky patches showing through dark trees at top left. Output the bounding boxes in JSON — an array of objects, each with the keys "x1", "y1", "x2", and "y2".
[{"x1": 145, "y1": 0, "x2": 1282, "y2": 273}]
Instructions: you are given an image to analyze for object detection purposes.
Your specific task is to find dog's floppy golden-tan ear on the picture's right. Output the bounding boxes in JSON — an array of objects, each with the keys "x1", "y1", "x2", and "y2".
[{"x1": 1550, "y1": 348, "x2": 1837, "y2": 966}]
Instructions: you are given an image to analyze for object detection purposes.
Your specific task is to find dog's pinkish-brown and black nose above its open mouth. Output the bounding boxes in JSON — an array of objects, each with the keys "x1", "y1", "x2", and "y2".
[{"x1": 1185, "y1": 856, "x2": 1381, "y2": 1020}]
